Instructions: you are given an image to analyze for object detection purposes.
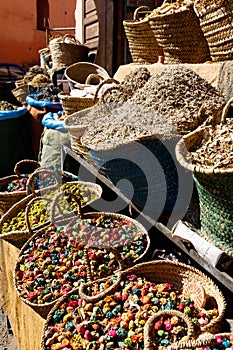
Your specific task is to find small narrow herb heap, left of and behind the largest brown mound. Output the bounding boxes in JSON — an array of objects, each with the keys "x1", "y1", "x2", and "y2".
[{"x1": 101, "y1": 67, "x2": 151, "y2": 103}]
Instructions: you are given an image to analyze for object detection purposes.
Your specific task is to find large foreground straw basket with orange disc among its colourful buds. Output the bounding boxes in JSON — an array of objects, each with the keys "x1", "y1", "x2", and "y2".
[{"x1": 41, "y1": 260, "x2": 226, "y2": 350}]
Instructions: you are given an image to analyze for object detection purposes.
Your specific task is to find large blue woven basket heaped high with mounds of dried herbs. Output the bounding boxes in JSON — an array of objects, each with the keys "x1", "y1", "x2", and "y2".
[{"x1": 76, "y1": 66, "x2": 225, "y2": 219}]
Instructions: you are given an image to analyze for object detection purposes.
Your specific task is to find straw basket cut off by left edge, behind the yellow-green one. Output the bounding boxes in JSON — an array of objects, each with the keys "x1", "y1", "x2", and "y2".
[{"x1": 0, "y1": 159, "x2": 40, "y2": 215}]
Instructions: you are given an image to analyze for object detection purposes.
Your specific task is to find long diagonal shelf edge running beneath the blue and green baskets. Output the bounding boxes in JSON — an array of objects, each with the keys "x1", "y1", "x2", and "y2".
[{"x1": 61, "y1": 145, "x2": 233, "y2": 297}]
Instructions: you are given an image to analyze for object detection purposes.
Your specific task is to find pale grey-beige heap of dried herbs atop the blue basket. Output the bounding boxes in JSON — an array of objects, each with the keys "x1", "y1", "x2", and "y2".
[{"x1": 79, "y1": 101, "x2": 177, "y2": 150}]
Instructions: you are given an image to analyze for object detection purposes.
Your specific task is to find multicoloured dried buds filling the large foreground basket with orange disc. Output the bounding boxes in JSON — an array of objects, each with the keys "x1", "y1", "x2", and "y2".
[{"x1": 41, "y1": 274, "x2": 218, "y2": 350}]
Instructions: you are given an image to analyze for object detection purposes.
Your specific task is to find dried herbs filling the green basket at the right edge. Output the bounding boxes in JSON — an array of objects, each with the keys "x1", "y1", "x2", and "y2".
[{"x1": 190, "y1": 119, "x2": 233, "y2": 169}]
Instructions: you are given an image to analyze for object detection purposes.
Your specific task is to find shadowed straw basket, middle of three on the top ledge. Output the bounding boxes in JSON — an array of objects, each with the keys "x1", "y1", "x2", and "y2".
[{"x1": 149, "y1": 4, "x2": 210, "y2": 64}]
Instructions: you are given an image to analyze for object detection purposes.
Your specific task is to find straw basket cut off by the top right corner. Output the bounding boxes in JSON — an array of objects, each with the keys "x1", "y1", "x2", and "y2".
[{"x1": 194, "y1": 0, "x2": 233, "y2": 62}]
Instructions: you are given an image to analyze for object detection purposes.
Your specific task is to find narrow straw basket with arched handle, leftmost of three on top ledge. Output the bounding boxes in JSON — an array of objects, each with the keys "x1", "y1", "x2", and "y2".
[{"x1": 123, "y1": 6, "x2": 163, "y2": 64}]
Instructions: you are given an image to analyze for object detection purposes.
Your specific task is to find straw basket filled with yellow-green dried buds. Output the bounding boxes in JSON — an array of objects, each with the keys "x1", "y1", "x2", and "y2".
[{"x1": 0, "y1": 168, "x2": 102, "y2": 248}]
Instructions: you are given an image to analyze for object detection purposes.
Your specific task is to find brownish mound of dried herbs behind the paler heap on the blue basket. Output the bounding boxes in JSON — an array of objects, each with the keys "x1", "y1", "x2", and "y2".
[{"x1": 130, "y1": 65, "x2": 225, "y2": 134}]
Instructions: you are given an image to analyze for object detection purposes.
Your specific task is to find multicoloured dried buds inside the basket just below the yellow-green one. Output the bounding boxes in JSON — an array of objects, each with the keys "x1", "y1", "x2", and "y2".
[{"x1": 15, "y1": 215, "x2": 147, "y2": 304}]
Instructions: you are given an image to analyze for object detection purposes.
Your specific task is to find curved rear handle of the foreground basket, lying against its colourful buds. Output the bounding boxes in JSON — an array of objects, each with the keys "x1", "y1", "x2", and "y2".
[{"x1": 79, "y1": 271, "x2": 123, "y2": 303}]
